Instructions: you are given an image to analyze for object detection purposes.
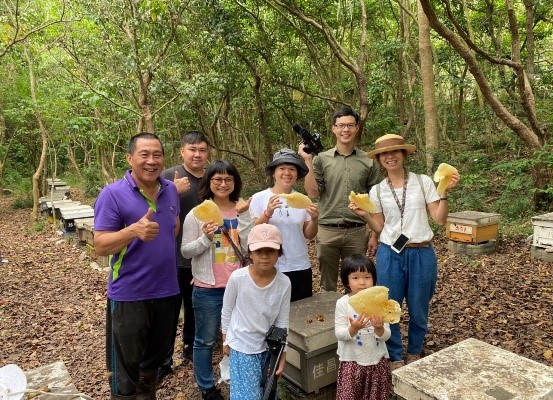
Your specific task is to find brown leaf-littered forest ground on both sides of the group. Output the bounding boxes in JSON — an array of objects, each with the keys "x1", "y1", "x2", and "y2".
[{"x1": 0, "y1": 193, "x2": 553, "y2": 400}]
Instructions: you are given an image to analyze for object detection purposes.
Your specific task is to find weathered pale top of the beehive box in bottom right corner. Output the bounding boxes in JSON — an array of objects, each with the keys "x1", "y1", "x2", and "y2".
[{"x1": 392, "y1": 338, "x2": 553, "y2": 400}]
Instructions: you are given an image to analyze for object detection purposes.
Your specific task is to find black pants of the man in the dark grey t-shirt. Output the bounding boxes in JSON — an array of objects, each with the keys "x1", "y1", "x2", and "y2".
[{"x1": 163, "y1": 267, "x2": 196, "y2": 367}]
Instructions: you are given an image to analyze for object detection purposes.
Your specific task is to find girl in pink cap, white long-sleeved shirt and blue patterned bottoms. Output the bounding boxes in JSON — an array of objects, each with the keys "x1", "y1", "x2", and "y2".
[{"x1": 221, "y1": 224, "x2": 291, "y2": 400}]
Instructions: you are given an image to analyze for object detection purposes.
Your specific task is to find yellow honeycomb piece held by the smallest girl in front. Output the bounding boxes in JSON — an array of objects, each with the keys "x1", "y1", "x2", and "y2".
[{"x1": 348, "y1": 286, "x2": 401, "y2": 324}]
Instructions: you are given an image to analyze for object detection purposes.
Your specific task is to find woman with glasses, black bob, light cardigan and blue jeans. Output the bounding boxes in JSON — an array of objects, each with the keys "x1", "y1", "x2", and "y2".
[{"x1": 181, "y1": 160, "x2": 253, "y2": 400}]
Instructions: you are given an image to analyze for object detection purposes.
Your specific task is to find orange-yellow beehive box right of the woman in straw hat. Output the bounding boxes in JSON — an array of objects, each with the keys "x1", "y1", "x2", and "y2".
[{"x1": 445, "y1": 211, "x2": 500, "y2": 243}]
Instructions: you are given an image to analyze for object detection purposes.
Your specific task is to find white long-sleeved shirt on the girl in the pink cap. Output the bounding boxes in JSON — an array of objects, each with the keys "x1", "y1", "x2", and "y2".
[{"x1": 221, "y1": 266, "x2": 292, "y2": 354}]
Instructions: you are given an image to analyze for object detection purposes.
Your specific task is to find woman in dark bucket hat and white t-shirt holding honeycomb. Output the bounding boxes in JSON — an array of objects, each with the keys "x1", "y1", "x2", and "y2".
[{"x1": 250, "y1": 149, "x2": 319, "y2": 301}]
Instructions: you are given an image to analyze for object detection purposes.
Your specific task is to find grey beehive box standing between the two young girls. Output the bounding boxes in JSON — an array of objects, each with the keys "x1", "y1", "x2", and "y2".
[{"x1": 284, "y1": 292, "x2": 342, "y2": 393}]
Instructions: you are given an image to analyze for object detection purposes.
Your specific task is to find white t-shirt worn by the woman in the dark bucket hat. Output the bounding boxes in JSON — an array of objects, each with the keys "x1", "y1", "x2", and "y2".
[{"x1": 250, "y1": 189, "x2": 311, "y2": 272}]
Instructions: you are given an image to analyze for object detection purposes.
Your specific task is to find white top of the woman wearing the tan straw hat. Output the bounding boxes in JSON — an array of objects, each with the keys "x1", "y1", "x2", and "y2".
[{"x1": 370, "y1": 172, "x2": 440, "y2": 245}]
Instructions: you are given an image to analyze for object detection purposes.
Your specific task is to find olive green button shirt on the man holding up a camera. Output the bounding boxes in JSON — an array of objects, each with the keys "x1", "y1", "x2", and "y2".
[{"x1": 313, "y1": 147, "x2": 381, "y2": 225}]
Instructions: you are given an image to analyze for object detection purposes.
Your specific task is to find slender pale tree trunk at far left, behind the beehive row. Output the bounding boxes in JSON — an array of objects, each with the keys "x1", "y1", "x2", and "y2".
[{"x1": 23, "y1": 43, "x2": 48, "y2": 221}]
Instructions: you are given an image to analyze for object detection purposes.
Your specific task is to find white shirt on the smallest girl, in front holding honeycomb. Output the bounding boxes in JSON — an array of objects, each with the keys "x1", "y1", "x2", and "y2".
[{"x1": 334, "y1": 294, "x2": 391, "y2": 365}]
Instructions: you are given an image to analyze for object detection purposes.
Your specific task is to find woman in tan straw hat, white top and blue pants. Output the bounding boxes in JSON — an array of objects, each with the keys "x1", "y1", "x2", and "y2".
[{"x1": 350, "y1": 134, "x2": 460, "y2": 369}]
